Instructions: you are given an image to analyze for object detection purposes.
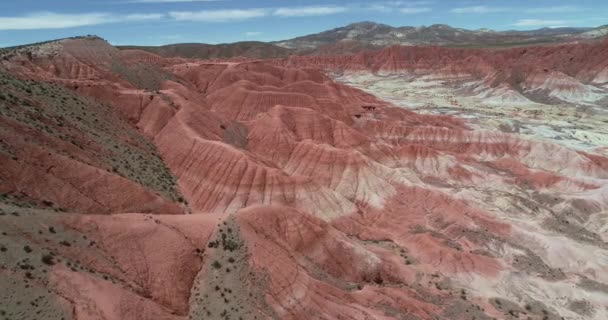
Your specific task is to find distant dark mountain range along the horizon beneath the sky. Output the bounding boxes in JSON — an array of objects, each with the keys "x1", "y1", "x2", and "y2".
[{"x1": 120, "y1": 22, "x2": 608, "y2": 59}]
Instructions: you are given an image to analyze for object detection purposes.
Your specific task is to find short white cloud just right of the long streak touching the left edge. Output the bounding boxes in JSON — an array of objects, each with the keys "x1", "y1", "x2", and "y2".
[{"x1": 169, "y1": 9, "x2": 268, "y2": 22}]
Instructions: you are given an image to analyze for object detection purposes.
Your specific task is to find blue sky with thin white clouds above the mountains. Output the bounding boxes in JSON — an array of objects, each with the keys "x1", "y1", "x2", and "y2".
[{"x1": 0, "y1": 0, "x2": 608, "y2": 47}]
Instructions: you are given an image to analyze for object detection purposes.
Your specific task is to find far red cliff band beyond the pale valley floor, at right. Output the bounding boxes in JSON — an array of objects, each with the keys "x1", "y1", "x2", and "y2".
[{"x1": 277, "y1": 40, "x2": 608, "y2": 104}]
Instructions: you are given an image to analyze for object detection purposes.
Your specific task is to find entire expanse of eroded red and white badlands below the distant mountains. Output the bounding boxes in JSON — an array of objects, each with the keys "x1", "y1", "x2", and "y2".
[{"x1": 0, "y1": 31, "x2": 608, "y2": 320}]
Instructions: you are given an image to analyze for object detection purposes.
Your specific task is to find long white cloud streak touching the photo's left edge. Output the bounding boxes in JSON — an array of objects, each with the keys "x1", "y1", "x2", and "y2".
[{"x1": 0, "y1": 12, "x2": 164, "y2": 30}]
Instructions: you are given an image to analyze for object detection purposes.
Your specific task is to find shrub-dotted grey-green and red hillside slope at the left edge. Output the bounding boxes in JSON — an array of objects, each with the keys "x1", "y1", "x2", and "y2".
[{"x1": 0, "y1": 69, "x2": 184, "y2": 214}]
